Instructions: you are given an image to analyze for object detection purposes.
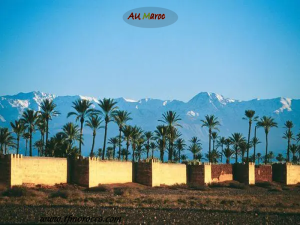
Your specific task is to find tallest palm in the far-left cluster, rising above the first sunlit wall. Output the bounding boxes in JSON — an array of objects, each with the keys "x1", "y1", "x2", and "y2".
[{"x1": 40, "y1": 99, "x2": 60, "y2": 149}]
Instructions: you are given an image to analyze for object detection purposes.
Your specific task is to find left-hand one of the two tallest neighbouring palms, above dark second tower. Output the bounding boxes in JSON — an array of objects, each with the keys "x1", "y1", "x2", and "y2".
[{"x1": 67, "y1": 99, "x2": 94, "y2": 155}]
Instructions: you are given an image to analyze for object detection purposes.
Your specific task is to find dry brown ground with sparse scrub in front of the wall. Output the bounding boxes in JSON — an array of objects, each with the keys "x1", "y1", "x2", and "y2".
[{"x1": 0, "y1": 182, "x2": 300, "y2": 224}]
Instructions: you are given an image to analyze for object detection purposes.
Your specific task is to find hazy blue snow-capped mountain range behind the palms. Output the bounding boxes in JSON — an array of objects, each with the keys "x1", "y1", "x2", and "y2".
[{"x1": 0, "y1": 91, "x2": 300, "y2": 158}]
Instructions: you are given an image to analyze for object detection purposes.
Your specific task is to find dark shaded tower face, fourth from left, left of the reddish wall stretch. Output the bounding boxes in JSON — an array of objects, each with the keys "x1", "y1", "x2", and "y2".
[{"x1": 186, "y1": 165, "x2": 205, "y2": 187}]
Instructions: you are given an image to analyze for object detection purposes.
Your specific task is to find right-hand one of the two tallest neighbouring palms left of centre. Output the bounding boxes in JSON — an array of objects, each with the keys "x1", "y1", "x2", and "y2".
[{"x1": 98, "y1": 98, "x2": 118, "y2": 159}]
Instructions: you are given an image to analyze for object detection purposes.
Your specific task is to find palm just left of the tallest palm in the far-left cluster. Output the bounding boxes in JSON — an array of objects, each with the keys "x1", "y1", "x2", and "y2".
[{"x1": 21, "y1": 109, "x2": 39, "y2": 156}]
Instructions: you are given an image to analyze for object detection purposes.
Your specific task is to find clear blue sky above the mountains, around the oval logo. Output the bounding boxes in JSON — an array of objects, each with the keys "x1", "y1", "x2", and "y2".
[{"x1": 0, "y1": 0, "x2": 300, "y2": 101}]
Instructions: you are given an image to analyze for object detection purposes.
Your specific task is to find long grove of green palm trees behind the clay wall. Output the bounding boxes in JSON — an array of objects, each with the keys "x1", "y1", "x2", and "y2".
[{"x1": 0, "y1": 98, "x2": 300, "y2": 163}]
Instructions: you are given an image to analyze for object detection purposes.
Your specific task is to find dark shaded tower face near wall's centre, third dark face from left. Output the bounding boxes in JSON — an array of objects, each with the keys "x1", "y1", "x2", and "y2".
[{"x1": 133, "y1": 162, "x2": 152, "y2": 187}]
